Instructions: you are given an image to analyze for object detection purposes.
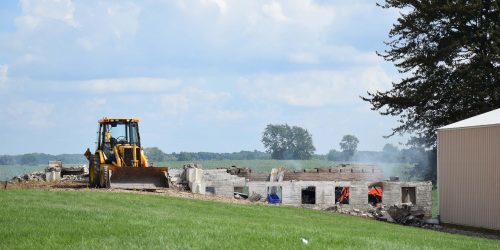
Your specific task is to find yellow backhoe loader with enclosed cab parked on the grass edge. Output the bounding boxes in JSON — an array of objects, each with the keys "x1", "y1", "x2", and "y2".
[{"x1": 85, "y1": 118, "x2": 168, "y2": 189}]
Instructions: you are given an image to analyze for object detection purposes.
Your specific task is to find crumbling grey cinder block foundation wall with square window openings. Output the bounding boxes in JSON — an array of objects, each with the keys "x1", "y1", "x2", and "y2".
[{"x1": 169, "y1": 165, "x2": 432, "y2": 218}]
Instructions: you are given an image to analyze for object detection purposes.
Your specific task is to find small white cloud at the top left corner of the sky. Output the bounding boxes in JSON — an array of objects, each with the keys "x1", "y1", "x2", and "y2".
[{"x1": 16, "y1": 0, "x2": 78, "y2": 30}]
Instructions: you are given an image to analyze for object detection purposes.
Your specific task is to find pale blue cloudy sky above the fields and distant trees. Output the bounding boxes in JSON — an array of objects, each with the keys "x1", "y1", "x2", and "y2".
[{"x1": 0, "y1": 0, "x2": 404, "y2": 154}]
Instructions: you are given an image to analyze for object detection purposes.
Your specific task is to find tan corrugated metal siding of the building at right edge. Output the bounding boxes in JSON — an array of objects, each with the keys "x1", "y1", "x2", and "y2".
[{"x1": 438, "y1": 125, "x2": 500, "y2": 230}]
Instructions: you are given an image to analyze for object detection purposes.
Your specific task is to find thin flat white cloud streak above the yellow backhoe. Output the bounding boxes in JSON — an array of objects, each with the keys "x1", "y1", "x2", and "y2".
[{"x1": 83, "y1": 77, "x2": 180, "y2": 93}]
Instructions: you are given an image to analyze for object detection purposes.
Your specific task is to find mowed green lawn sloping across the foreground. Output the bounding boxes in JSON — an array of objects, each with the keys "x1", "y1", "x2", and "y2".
[{"x1": 0, "y1": 189, "x2": 500, "y2": 249}]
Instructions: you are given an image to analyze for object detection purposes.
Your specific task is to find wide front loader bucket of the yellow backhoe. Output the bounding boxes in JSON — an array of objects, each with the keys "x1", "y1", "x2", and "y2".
[{"x1": 110, "y1": 167, "x2": 168, "y2": 189}]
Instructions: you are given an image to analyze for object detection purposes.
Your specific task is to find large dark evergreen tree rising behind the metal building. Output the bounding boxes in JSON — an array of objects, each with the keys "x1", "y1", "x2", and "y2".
[{"x1": 362, "y1": 0, "x2": 500, "y2": 147}]
